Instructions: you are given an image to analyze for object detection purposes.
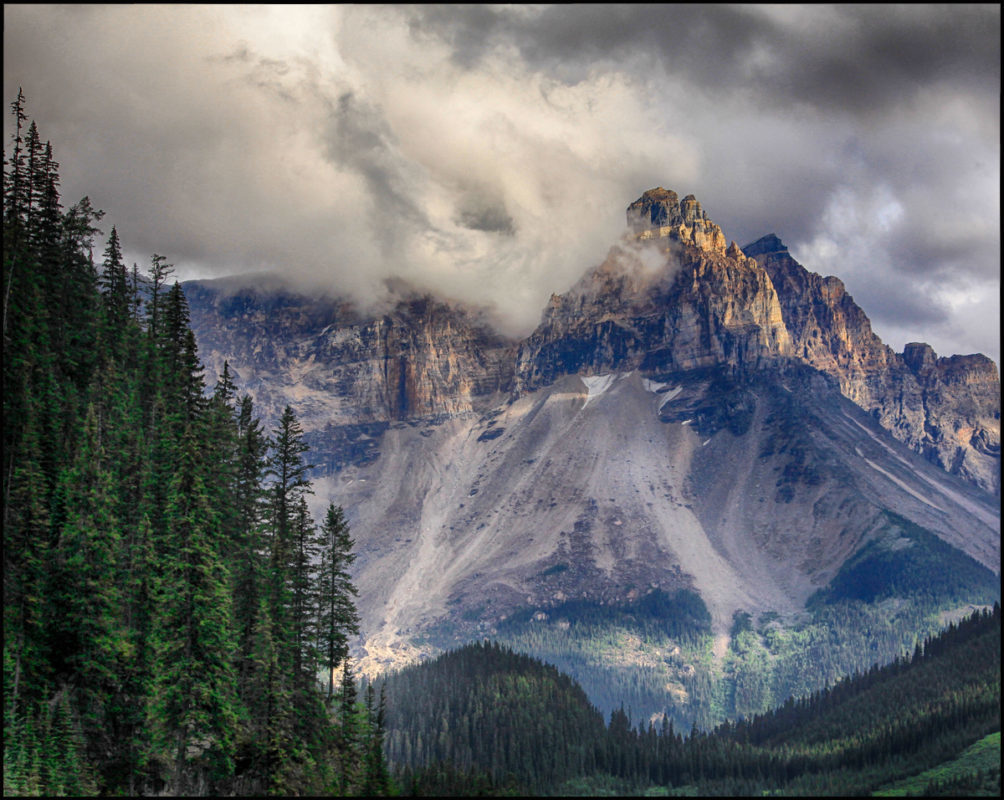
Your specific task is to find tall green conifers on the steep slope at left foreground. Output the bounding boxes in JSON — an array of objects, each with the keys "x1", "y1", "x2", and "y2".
[{"x1": 3, "y1": 92, "x2": 390, "y2": 795}]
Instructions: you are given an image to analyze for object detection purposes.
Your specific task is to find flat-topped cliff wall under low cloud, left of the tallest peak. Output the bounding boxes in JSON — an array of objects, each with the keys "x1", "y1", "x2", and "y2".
[{"x1": 186, "y1": 281, "x2": 513, "y2": 432}]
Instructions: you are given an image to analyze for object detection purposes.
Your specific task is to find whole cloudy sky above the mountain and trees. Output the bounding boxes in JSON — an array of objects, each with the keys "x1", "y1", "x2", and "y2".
[{"x1": 3, "y1": 4, "x2": 1001, "y2": 363}]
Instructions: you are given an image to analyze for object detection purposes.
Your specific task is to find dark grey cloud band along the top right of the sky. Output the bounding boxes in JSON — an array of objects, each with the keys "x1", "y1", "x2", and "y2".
[{"x1": 408, "y1": 3, "x2": 1000, "y2": 112}]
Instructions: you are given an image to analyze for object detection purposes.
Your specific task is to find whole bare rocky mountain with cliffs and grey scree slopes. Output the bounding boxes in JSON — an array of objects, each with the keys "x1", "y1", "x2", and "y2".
[{"x1": 185, "y1": 189, "x2": 1000, "y2": 686}]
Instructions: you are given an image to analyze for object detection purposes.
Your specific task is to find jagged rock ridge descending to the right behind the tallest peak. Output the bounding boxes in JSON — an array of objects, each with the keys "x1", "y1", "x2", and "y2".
[{"x1": 743, "y1": 234, "x2": 1000, "y2": 496}]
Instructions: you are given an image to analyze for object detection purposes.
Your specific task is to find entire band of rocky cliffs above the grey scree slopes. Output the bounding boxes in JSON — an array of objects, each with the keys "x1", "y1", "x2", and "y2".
[{"x1": 186, "y1": 188, "x2": 1000, "y2": 495}]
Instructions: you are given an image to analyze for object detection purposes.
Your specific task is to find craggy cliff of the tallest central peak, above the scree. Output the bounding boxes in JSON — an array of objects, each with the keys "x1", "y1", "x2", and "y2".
[{"x1": 515, "y1": 189, "x2": 791, "y2": 393}]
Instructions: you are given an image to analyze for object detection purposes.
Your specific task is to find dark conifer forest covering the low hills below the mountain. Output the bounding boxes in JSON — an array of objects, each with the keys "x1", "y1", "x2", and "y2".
[{"x1": 381, "y1": 604, "x2": 1001, "y2": 796}]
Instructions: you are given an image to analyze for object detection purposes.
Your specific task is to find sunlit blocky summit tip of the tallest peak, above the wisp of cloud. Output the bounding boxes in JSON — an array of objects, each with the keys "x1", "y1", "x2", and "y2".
[{"x1": 628, "y1": 187, "x2": 726, "y2": 253}]
